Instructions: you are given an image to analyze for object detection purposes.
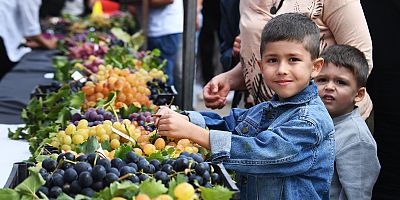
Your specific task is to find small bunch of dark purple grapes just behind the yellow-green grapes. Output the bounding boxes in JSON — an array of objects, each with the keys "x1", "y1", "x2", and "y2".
[{"x1": 72, "y1": 108, "x2": 115, "y2": 127}]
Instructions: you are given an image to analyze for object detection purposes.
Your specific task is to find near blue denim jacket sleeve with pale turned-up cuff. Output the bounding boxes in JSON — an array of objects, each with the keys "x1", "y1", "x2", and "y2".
[{"x1": 210, "y1": 119, "x2": 322, "y2": 176}]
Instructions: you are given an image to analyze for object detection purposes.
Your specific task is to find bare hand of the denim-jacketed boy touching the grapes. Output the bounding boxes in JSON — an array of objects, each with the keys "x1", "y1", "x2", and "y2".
[{"x1": 156, "y1": 111, "x2": 196, "y2": 139}]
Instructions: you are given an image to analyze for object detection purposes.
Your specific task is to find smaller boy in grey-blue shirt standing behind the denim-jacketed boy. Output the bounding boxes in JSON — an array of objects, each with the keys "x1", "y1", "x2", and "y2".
[{"x1": 315, "y1": 45, "x2": 380, "y2": 200}]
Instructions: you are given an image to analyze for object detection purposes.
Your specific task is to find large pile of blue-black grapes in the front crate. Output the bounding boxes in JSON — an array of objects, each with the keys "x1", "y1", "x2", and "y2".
[{"x1": 38, "y1": 152, "x2": 222, "y2": 198}]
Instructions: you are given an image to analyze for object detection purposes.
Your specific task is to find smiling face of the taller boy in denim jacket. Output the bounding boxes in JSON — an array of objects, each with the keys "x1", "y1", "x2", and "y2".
[{"x1": 259, "y1": 41, "x2": 323, "y2": 99}]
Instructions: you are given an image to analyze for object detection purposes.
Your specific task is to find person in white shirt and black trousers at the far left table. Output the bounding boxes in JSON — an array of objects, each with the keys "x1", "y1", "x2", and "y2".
[{"x1": 0, "y1": 0, "x2": 56, "y2": 79}]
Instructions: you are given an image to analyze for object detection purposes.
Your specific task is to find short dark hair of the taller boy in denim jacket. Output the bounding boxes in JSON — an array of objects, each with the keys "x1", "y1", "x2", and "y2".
[{"x1": 260, "y1": 13, "x2": 320, "y2": 59}]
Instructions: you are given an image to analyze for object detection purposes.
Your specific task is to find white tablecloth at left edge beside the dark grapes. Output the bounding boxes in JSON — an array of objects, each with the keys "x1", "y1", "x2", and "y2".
[{"x1": 0, "y1": 124, "x2": 31, "y2": 188}]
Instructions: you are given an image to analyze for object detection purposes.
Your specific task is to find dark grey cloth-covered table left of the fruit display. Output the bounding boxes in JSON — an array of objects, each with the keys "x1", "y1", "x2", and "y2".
[{"x1": 0, "y1": 50, "x2": 59, "y2": 124}]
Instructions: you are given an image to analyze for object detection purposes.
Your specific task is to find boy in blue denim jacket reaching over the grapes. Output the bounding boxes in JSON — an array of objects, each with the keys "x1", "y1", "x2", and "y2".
[{"x1": 156, "y1": 13, "x2": 335, "y2": 200}]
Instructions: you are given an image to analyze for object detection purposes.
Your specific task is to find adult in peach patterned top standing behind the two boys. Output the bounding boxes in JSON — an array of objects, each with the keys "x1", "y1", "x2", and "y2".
[{"x1": 203, "y1": 0, "x2": 372, "y2": 119}]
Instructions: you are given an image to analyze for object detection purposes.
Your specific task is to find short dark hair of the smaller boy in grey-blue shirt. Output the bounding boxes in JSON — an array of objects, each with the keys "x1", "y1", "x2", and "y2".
[{"x1": 321, "y1": 44, "x2": 369, "y2": 87}]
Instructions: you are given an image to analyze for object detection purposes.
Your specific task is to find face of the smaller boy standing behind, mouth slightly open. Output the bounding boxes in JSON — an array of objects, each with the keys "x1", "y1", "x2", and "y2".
[{"x1": 315, "y1": 63, "x2": 365, "y2": 118}]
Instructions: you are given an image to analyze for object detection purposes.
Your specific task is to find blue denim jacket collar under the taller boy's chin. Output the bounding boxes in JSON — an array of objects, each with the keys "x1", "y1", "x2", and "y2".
[{"x1": 270, "y1": 80, "x2": 318, "y2": 107}]
